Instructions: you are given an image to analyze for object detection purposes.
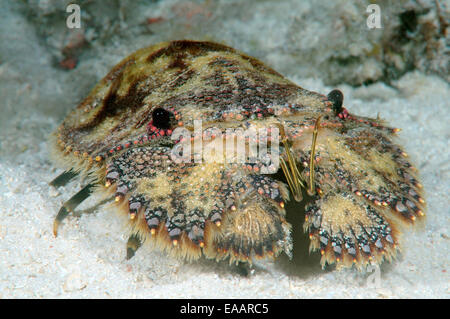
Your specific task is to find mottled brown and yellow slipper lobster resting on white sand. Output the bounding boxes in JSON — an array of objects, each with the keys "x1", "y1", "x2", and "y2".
[{"x1": 52, "y1": 40, "x2": 424, "y2": 268}]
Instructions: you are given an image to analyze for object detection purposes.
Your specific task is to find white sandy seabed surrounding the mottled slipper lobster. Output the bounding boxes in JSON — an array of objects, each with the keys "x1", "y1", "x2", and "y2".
[{"x1": 0, "y1": 1, "x2": 450, "y2": 298}]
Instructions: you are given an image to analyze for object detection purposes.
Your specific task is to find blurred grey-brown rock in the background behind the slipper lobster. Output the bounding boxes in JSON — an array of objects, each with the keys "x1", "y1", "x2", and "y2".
[{"x1": 15, "y1": 0, "x2": 450, "y2": 85}]
